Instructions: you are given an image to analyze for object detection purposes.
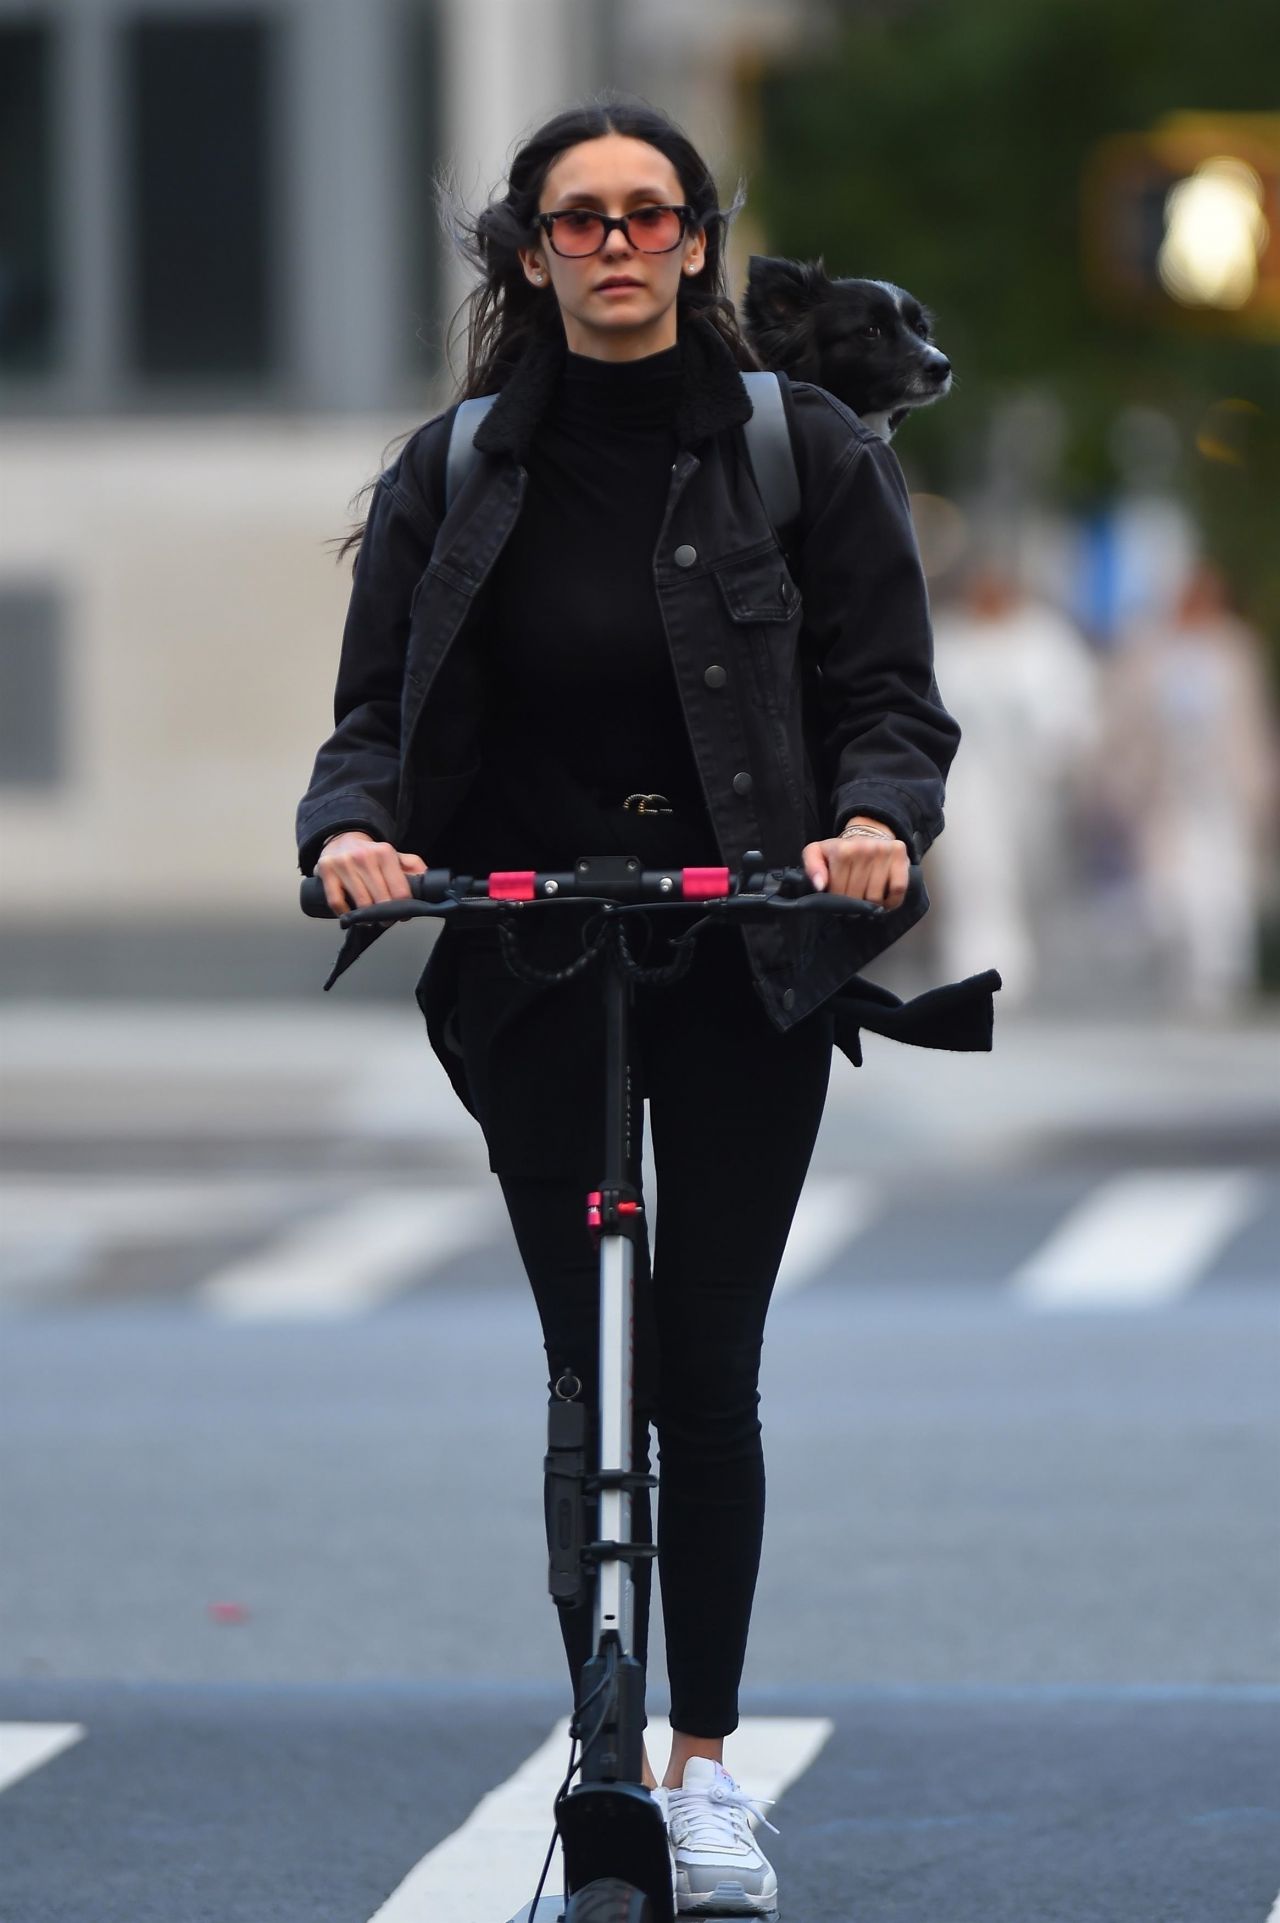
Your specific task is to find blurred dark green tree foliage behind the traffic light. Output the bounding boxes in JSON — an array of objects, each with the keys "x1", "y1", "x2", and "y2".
[{"x1": 751, "y1": 0, "x2": 1280, "y2": 658}]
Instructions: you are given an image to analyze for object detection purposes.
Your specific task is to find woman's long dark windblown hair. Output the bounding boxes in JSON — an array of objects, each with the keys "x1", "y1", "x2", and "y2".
[{"x1": 338, "y1": 90, "x2": 759, "y2": 560}]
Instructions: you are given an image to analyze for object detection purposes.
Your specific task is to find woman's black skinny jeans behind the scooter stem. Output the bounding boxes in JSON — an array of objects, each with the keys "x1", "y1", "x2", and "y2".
[{"x1": 457, "y1": 912, "x2": 832, "y2": 1736}]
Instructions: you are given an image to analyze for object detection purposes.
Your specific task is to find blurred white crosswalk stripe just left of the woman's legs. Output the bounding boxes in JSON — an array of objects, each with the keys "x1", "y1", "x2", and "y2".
[{"x1": 198, "y1": 1188, "x2": 488, "y2": 1321}]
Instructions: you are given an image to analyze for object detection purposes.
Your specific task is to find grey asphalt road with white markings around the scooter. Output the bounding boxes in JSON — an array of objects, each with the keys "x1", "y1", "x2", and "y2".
[{"x1": 0, "y1": 1035, "x2": 1280, "y2": 1923}]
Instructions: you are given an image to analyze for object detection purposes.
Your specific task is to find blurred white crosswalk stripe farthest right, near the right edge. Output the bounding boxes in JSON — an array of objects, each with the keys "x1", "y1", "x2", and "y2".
[{"x1": 1011, "y1": 1169, "x2": 1263, "y2": 1310}]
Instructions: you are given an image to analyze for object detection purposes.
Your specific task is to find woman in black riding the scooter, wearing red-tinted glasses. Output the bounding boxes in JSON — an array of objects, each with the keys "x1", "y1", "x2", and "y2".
[{"x1": 298, "y1": 102, "x2": 994, "y2": 1913}]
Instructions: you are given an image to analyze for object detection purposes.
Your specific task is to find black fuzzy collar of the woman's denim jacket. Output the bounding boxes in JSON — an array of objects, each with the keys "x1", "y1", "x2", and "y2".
[{"x1": 475, "y1": 315, "x2": 751, "y2": 460}]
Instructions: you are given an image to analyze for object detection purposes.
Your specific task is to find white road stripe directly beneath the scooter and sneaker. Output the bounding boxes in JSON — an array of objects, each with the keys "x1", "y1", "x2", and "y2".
[{"x1": 371, "y1": 1717, "x2": 834, "y2": 1923}]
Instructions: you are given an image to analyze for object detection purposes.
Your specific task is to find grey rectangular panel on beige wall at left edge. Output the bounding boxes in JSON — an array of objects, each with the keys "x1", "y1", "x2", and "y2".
[{"x1": 0, "y1": 583, "x2": 65, "y2": 788}]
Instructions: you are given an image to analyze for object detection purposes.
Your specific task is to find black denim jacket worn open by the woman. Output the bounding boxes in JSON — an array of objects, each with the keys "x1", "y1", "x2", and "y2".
[{"x1": 298, "y1": 321, "x2": 997, "y2": 1046}]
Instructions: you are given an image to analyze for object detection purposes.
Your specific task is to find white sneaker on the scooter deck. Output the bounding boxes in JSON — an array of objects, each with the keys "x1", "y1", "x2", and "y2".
[{"x1": 650, "y1": 1756, "x2": 778, "y2": 1917}]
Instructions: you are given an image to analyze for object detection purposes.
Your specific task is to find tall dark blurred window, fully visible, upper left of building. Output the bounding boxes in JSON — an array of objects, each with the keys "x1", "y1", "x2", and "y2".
[{"x1": 125, "y1": 15, "x2": 281, "y2": 379}]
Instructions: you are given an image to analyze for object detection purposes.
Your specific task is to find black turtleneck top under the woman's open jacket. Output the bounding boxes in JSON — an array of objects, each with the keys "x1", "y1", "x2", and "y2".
[{"x1": 453, "y1": 346, "x2": 719, "y2": 865}]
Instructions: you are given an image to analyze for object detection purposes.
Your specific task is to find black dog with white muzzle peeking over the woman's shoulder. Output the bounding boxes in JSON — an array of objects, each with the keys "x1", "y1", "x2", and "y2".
[{"x1": 742, "y1": 254, "x2": 951, "y2": 440}]
